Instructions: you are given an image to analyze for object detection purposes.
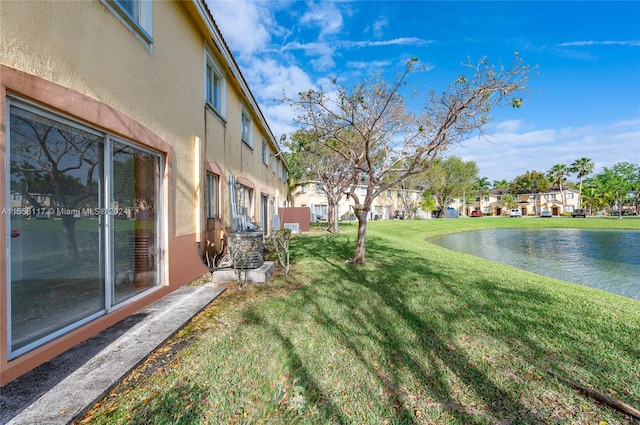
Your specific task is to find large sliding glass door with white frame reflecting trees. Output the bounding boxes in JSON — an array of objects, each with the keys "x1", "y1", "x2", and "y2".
[{"x1": 3, "y1": 99, "x2": 162, "y2": 358}]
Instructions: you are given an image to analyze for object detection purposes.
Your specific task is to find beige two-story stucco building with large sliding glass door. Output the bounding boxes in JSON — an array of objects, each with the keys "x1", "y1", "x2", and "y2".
[{"x1": 0, "y1": 0, "x2": 287, "y2": 384}]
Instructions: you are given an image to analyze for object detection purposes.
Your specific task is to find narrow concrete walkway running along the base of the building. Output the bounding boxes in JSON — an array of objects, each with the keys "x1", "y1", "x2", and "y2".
[{"x1": 0, "y1": 285, "x2": 225, "y2": 425}]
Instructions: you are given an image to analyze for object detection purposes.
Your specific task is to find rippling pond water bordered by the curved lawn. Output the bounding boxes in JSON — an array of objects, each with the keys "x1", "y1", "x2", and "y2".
[{"x1": 429, "y1": 229, "x2": 640, "y2": 299}]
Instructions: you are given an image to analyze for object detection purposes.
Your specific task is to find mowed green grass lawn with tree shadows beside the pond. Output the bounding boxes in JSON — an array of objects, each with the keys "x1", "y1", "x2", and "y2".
[{"x1": 78, "y1": 217, "x2": 640, "y2": 424}]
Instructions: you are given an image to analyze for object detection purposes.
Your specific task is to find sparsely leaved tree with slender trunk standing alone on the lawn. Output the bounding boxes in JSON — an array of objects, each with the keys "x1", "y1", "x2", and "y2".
[{"x1": 287, "y1": 54, "x2": 529, "y2": 263}]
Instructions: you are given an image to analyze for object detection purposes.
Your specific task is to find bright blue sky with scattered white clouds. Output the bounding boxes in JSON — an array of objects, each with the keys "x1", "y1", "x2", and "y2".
[{"x1": 208, "y1": 0, "x2": 640, "y2": 181}]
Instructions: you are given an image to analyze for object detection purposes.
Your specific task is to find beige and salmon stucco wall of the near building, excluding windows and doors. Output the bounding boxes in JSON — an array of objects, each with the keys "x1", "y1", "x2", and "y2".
[{"x1": 0, "y1": 0, "x2": 285, "y2": 383}]
